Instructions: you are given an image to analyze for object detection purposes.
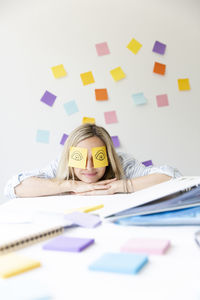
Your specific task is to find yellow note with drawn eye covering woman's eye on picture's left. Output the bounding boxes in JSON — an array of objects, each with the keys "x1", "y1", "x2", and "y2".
[{"x1": 68, "y1": 147, "x2": 87, "y2": 169}]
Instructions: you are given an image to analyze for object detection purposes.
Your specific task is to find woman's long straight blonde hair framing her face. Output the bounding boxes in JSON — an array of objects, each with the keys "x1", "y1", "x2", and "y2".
[{"x1": 56, "y1": 124, "x2": 124, "y2": 180}]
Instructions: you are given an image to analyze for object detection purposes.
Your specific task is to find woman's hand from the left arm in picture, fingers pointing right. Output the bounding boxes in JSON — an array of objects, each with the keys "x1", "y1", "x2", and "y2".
[{"x1": 66, "y1": 178, "x2": 116, "y2": 195}]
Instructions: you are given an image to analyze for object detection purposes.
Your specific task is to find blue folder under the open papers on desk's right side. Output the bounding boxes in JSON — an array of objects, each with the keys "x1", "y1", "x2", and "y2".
[{"x1": 114, "y1": 206, "x2": 200, "y2": 226}]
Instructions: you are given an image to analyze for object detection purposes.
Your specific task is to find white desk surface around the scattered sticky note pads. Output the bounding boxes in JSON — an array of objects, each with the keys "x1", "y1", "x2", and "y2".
[{"x1": 0, "y1": 196, "x2": 200, "y2": 300}]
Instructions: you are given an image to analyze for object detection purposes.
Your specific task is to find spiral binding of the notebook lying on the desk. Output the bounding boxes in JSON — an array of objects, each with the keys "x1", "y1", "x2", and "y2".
[{"x1": 0, "y1": 226, "x2": 65, "y2": 255}]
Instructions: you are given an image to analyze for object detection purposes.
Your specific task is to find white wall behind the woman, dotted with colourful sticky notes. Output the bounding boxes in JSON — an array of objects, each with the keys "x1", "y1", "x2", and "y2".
[{"x1": 0, "y1": 0, "x2": 200, "y2": 199}]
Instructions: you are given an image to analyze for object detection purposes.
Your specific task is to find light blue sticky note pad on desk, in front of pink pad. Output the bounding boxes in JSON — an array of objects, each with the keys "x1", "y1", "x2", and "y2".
[{"x1": 89, "y1": 253, "x2": 148, "y2": 274}]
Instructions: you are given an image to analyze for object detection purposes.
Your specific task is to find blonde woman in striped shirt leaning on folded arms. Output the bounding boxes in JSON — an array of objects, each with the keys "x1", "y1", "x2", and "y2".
[{"x1": 5, "y1": 124, "x2": 181, "y2": 198}]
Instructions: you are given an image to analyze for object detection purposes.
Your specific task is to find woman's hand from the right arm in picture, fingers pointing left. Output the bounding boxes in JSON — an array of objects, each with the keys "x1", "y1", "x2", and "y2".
[{"x1": 71, "y1": 179, "x2": 127, "y2": 196}]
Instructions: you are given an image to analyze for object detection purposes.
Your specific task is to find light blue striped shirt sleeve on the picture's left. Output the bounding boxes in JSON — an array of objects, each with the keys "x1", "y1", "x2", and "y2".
[{"x1": 4, "y1": 159, "x2": 58, "y2": 199}]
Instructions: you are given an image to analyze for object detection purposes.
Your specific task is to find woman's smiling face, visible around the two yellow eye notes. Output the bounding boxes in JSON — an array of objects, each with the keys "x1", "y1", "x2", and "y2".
[{"x1": 74, "y1": 136, "x2": 106, "y2": 183}]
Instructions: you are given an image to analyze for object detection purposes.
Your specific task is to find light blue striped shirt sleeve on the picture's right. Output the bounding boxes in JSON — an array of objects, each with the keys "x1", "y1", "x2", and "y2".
[{"x1": 118, "y1": 153, "x2": 182, "y2": 179}]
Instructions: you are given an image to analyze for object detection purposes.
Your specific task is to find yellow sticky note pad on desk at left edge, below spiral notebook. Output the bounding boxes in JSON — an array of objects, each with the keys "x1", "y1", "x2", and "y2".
[{"x1": 0, "y1": 253, "x2": 40, "y2": 278}]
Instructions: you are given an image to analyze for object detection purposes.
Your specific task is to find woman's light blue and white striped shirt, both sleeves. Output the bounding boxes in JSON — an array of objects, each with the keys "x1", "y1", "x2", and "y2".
[{"x1": 4, "y1": 152, "x2": 182, "y2": 199}]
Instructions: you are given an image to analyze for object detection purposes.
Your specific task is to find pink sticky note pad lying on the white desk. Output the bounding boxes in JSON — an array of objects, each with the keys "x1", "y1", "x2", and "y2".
[{"x1": 121, "y1": 238, "x2": 170, "y2": 254}]
